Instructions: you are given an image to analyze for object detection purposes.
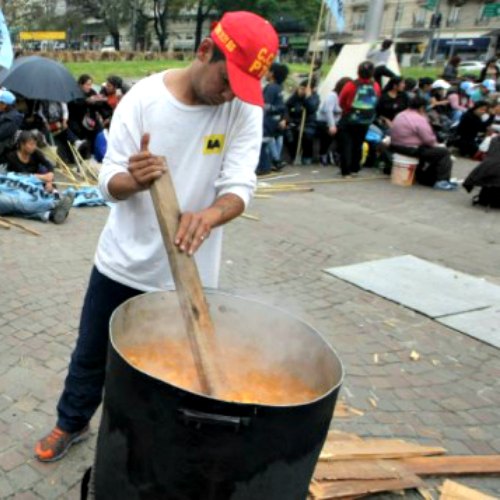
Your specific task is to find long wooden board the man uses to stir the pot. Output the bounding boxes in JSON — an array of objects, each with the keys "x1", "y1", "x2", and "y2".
[{"x1": 147, "y1": 158, "x2": 221, "y2": 395}]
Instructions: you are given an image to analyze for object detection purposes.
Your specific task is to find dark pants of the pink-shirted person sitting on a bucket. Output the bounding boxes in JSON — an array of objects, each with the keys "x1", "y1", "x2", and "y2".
[{"x1": 391, "y1": 144, "x2": 453, "y2": 186}]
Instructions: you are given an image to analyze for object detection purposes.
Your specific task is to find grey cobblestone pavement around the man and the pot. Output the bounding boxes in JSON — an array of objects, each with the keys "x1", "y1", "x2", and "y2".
[{"x1": 0, "y1": 161, "x2": 500, "y2": 500}]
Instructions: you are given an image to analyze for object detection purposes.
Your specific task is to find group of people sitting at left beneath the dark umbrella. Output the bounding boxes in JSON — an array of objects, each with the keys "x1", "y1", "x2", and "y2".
[{"x1": 0, "y1": 74, "x2": 127, "y2": 224}]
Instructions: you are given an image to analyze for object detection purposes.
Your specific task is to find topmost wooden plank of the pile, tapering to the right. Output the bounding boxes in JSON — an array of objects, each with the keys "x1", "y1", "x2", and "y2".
[{"x1": 320, "y1": 439, "x2": 446, "y2": 460}]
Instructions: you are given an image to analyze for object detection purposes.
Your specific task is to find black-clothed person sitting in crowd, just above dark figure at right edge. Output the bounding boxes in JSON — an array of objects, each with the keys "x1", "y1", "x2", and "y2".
[{"x1": 454, "y1": 101, "x2": 493, "y2": 158}]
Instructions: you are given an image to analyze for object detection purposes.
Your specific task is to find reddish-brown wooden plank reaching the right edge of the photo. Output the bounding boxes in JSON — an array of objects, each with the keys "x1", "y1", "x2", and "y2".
[{"x1": 400, "y1": 455, "x2": 500, "y2": 476}]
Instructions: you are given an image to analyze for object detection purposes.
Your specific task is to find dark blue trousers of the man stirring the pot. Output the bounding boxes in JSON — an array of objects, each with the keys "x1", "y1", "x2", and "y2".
[{"x1": 57, "y1": 267, "x2": 142, "y2": 432}]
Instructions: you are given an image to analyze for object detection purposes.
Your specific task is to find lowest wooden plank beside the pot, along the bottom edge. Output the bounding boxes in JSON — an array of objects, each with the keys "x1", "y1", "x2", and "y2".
[{"x1": 310, "y1": 475, "x2": 424, "y2": 500}]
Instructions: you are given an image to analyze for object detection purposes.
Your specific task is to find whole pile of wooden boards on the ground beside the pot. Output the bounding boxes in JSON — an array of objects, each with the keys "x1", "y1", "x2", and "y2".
[{"x1": 309, "y1": 431, "x2": 500, "y2": 500}]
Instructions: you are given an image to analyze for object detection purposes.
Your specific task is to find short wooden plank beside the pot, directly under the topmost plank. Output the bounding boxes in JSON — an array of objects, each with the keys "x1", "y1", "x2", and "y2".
[{"x1": 314, "y1": 460, "x2": 409, "y2": 481}]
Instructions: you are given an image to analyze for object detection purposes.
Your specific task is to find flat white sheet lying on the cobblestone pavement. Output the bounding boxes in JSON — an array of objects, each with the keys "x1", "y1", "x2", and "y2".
[{"x1": 325, "y1": 255, "x2": 500, "y2": 349}]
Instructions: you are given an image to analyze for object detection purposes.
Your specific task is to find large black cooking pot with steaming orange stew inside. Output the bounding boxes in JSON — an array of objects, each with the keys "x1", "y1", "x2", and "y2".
[{"x1": 93, "y1": 292, "x2": 343, "y2": 500}]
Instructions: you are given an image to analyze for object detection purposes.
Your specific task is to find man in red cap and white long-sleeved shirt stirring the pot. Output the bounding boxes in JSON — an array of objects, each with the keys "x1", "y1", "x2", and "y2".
[{"x1": 35, "y1": 12, "x2": 278, "y2": 462}]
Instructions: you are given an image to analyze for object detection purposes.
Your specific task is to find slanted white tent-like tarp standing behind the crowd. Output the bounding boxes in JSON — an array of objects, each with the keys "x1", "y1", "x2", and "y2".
[{"x1": 319, "y1": 43, "x2": 400, "y2": 100}]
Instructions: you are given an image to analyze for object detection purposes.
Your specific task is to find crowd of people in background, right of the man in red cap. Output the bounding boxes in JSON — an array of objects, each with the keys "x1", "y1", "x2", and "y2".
[{"x1": 257, "y1": 40, "x2": 500, "y2": 190}]
